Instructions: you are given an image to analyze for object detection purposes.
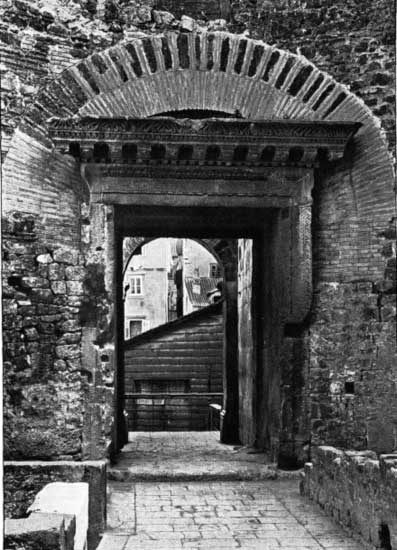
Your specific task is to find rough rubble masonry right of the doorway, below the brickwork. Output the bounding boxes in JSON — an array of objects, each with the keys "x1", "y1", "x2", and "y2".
[{"x1": 308, "y1": 282, "x2": 397, "y2": 453}]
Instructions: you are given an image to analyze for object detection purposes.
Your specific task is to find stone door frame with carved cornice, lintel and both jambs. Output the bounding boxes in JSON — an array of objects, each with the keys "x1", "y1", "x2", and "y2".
[{"x1": 57, "y1": 117, "x2": 359, "y2": 460}]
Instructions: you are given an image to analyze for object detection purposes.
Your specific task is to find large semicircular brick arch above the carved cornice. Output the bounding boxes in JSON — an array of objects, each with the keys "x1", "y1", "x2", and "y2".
[{"x1": 4, "y1": 28, "x2": 394, "y2": 274}]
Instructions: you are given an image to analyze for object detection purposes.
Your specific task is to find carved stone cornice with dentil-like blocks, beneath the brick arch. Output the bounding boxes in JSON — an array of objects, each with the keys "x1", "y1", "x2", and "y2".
[{"x1": 49, "y1": 117, "x2": 360, "y2": 169}]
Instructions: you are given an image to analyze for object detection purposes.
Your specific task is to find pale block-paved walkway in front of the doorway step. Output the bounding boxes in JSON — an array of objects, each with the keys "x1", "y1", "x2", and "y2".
[{"x1": 98, "y1": 480, "x2": 369, "y2": 550}]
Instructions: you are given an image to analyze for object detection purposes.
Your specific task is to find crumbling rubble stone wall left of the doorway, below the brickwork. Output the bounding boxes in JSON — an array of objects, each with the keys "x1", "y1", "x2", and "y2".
[{"x1": 2, "y1": 212, "x2": 86, "y2": 459}]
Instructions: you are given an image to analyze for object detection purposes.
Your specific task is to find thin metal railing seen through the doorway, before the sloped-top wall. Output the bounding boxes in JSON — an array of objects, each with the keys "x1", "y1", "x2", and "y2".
[{"x1": 125, "y1": 392, "x2": 223, "y2": 431}]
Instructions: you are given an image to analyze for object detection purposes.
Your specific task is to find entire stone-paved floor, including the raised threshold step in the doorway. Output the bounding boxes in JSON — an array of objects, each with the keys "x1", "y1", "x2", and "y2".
[{"x1": 98, "y1": 432, "x2": 368, "y2": 550}]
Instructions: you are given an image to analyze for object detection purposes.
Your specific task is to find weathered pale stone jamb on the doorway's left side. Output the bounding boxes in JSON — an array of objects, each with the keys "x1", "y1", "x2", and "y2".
[{"x1": 80, "y1": 203, "x2": 117, "y2": 460}]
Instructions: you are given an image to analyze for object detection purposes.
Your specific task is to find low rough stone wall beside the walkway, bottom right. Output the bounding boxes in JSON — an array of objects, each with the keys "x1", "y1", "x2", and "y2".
[{"x1": 301, "y1": 447, "x2": 397, "y2": 549}]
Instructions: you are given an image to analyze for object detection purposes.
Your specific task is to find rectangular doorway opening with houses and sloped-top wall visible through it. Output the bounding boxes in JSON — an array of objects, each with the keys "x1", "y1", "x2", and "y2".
[{"x1": 115, "y1": 206, "x2": 271, "y2": 460}]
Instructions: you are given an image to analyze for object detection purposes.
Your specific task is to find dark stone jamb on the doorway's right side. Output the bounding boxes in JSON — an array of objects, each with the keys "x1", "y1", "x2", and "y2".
[{"x1": 253, "y1": 171, "x2": 313, "y2": 466}]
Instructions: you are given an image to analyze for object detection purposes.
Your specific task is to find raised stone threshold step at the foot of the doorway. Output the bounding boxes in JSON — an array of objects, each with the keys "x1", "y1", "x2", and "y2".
[{"x1": 108, "y1": 431, "x2": 279, "y2": 481}]
